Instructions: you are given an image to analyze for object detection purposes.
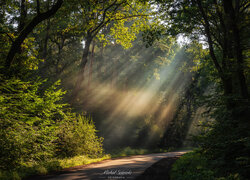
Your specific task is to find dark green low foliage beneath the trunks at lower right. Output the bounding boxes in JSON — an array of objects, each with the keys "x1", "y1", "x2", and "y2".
[{"x1": 195, "y1": 94, "x2": 250, "y2": 179}]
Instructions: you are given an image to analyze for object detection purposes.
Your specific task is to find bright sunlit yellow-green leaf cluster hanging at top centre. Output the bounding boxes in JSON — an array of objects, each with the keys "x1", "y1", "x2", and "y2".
[{"x1": 92, "y1": 1, "x2": 150, "y2": 49}]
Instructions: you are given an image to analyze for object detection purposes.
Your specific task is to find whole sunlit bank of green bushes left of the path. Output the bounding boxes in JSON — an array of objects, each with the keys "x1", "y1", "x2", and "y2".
[{"x1": 0, "y1": 76, "x2": 102, "y2": 171}]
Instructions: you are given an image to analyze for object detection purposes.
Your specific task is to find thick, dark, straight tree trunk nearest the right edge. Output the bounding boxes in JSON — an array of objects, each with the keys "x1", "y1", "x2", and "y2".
[{"x1": 223, "y1": 0, "x2": 249, "y2": 122}]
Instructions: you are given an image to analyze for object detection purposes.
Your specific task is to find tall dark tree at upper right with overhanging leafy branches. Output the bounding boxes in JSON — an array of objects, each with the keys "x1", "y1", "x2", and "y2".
[{"x1": 157, "y1": 0, "x2": 249, "y2": 108}]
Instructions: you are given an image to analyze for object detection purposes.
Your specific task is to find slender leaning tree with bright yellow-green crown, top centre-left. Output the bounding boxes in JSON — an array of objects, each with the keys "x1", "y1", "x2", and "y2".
[{"x1": 72, "y1": 0, "x2": 150, "y2": 100}]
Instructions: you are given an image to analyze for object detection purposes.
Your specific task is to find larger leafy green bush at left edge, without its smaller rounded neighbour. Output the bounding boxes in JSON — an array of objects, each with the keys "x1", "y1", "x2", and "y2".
[{"x1": 0, "y1": 78, "x2": 61, "y2": 169}]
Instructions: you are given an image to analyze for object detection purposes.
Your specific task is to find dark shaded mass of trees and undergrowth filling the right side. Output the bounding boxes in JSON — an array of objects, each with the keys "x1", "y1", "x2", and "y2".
[{"x1": 158, "y1": 0, "x2": 250, "y2": 179}]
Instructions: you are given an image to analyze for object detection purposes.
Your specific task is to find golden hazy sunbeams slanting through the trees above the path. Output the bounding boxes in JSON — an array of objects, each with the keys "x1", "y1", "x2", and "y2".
[{"x1": 66, "y1": 40, "x2": 195, "y2": 147}]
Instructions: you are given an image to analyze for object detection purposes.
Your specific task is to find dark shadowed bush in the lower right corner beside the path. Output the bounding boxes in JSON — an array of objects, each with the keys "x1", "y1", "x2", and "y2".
[{"x1": 194, "y1": 95, "x2": 250, "y2": 179}]
